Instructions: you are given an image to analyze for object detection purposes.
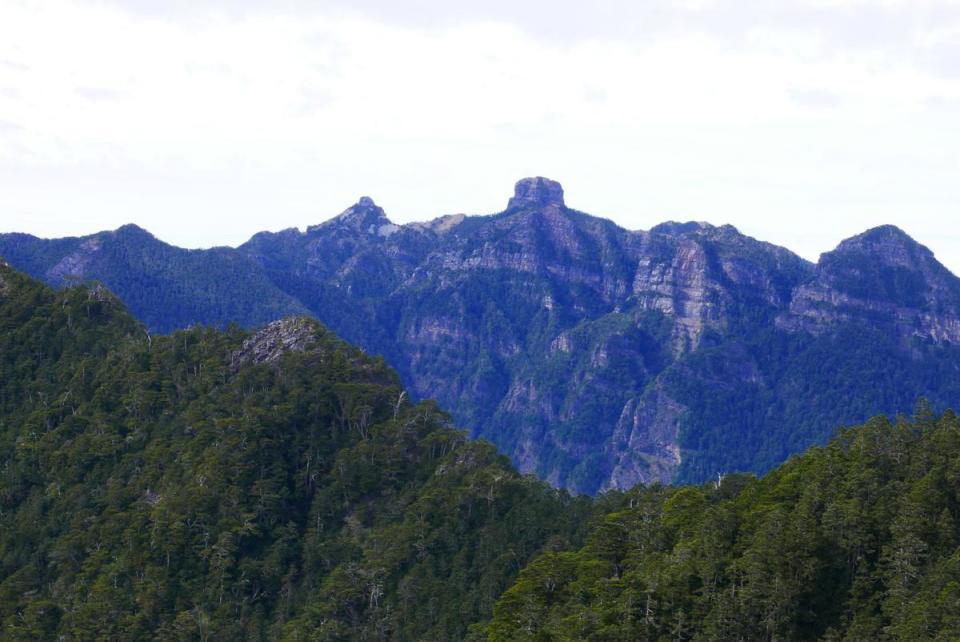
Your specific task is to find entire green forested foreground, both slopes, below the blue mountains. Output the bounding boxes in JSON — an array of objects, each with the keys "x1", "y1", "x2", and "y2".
[{"x1": 0, "y1": 262, "x2": 960, "y2": 641}]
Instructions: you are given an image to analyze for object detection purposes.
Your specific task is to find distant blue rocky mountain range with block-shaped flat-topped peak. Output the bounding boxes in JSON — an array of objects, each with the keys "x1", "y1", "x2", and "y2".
[{"x1": 0, "y1": 177, "x2": 960, "y2": 493}]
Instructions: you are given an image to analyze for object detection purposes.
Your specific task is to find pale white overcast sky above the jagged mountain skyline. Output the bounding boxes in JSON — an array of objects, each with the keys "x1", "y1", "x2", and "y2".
[{"x1": 0, "y1": 0, "x2": 960, "y2": 273}]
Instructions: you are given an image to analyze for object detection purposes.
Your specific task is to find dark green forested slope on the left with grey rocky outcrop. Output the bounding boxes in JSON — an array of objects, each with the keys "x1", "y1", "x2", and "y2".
[{"x1": 0, "y1": 265, "x2": 591, "y2": 640}]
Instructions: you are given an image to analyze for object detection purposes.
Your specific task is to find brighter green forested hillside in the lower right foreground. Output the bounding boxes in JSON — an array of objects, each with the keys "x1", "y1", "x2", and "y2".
[{"x1": 477, "y1": 410, "x2": 960, "y2": 642}]
